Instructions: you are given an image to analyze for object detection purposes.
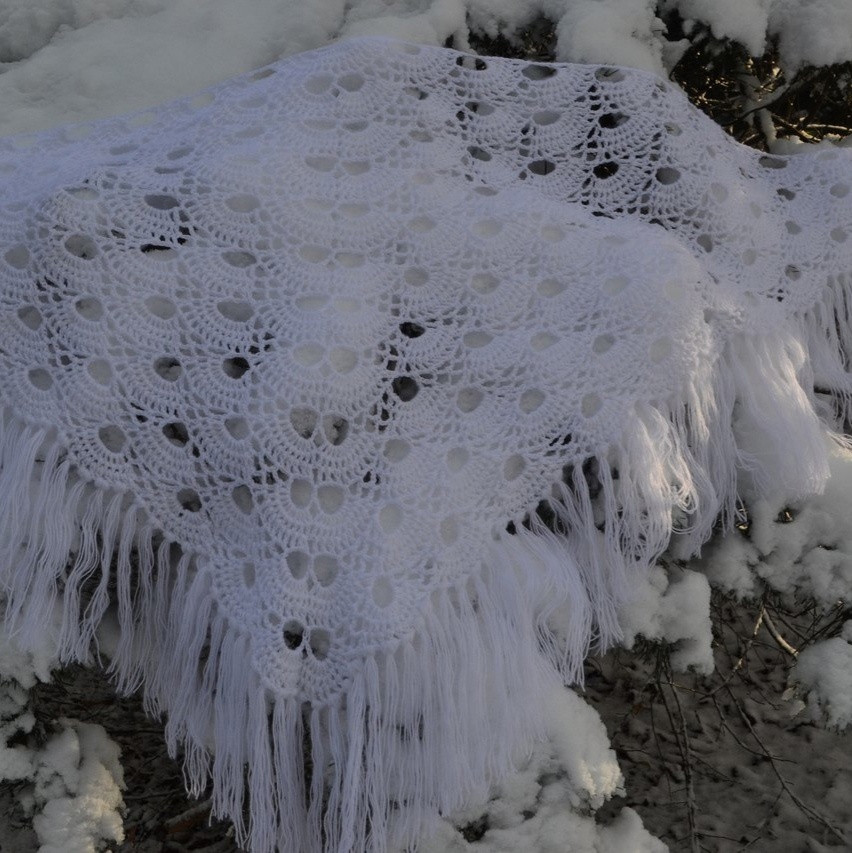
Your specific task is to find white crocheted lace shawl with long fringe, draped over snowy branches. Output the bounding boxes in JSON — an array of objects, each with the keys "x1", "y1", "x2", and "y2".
[{"x1": 0, "y1": 39, "x2": 852, "y2": 853}]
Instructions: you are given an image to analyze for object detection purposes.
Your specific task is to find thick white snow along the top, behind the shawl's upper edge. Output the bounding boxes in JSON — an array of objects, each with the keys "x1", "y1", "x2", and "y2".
[{"x1": 0, "y1": 0, "x2": 852, "y2": 135}]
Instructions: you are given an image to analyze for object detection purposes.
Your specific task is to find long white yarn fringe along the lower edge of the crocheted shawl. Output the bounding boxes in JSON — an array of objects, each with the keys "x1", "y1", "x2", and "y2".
[{"x1": 0, "y1": 297, "x2": 852, "y2": 853}]
